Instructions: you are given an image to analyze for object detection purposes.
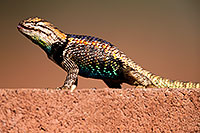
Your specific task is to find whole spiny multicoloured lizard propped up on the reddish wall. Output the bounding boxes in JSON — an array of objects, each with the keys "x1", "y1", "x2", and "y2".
[{"x1": 17, "y1": 16, "x2": 200, "y2": 91}]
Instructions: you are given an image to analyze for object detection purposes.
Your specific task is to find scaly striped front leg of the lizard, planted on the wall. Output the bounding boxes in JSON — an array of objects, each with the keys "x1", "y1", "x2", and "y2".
[{"x1": 61, "y1": 58, "x2": 79, "y2": 92}]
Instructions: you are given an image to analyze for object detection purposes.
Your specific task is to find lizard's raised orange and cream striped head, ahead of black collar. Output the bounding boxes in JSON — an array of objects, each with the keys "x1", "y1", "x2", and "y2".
[{"x1": 17, "y1": 17, "x2": 66, "y2": 52}]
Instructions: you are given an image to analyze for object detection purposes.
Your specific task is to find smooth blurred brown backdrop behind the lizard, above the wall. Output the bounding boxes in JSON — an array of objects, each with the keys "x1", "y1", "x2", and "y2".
[{"x1": 0, "y1": 0, "x2": 200, "y2": 88}]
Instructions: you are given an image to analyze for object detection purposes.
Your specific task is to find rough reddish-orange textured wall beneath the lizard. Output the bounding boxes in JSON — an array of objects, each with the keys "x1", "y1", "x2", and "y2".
[{"x1": 0, "y1": 89, "x2": 200, "y2": 132}]
